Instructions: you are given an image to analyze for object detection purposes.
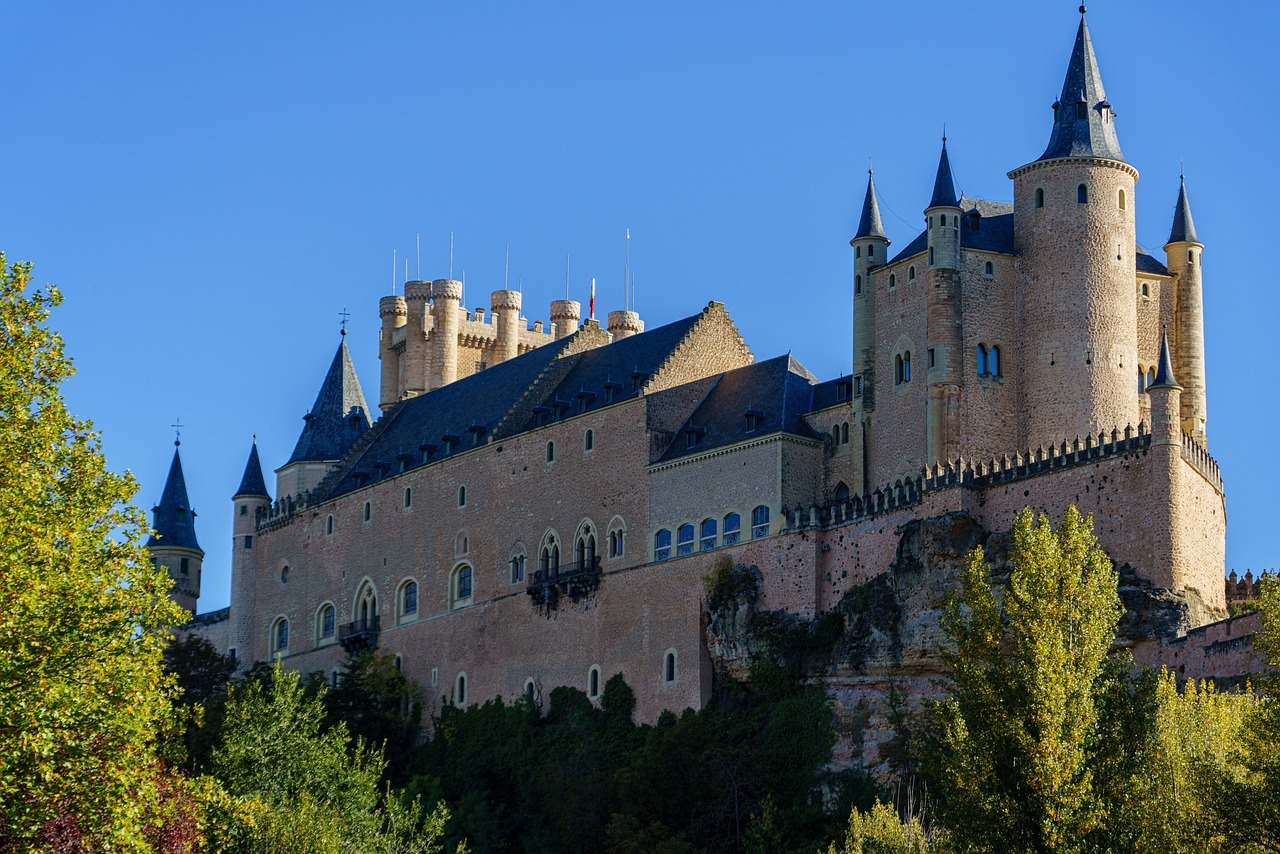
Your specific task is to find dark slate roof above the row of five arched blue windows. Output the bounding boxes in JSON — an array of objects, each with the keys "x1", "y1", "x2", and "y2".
[{"x1": 655, "y1": 355, "x2": 817, "y2": 462}]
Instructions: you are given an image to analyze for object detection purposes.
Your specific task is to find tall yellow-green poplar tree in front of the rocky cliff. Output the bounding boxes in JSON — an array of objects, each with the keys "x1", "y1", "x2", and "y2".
[{"x1": 929, "y1": 506, "x2": 1121, "y2": 851}]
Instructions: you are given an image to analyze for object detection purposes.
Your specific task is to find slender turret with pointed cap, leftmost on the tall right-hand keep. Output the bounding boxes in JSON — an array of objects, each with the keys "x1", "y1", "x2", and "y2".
[{"x1": 849, "y1": 169, "x2": 890, "y2": 492}]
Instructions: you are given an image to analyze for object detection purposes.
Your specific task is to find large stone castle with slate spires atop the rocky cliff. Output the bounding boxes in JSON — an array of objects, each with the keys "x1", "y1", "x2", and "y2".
[{"x1": 151, "y1": 8, "x2": 1259, "y2": 763}]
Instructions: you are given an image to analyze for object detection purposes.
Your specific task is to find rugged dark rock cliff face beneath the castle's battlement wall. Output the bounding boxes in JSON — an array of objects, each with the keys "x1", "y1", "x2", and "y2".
[{"x1": 707, "y1": 512, "x2": 1189, "y2": 775}]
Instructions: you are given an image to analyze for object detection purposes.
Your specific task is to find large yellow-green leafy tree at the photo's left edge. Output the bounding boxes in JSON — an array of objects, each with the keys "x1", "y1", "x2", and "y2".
[{"x1": 0, "y1": 254, "x2": 183, "y2": 849}]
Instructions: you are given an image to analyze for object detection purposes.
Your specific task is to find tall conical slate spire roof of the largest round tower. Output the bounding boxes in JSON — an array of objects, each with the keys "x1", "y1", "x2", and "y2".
[{"x1": 1038, "y1": 15, "x2": 1124, "y2": 161}]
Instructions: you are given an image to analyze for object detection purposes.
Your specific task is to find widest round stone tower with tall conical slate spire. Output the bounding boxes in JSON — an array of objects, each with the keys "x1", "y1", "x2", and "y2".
[{"x1": 1009, "y1": 6, "x2": 1138, "y2": 444}]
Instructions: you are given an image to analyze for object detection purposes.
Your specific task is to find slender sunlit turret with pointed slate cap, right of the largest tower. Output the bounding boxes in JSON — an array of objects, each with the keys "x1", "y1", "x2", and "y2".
[{"x1": 1165, "y1": 172, "x2": 1208, "y2": 447}]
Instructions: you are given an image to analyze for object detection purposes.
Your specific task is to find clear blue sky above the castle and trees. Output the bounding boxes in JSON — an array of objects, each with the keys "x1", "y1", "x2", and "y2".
[{"x1": 0, "y1": 0, "x2": 1280, "y2": 611}]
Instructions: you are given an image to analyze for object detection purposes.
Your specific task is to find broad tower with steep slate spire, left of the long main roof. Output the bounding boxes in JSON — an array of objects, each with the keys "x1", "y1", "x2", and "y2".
[{"x1": 275, "y1": 328, "x2": 368, "y2": 498}]
